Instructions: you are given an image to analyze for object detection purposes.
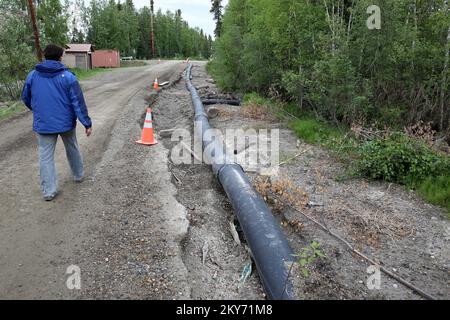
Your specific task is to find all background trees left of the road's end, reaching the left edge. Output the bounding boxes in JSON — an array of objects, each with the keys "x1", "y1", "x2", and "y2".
[{"x1": 0, "y1": 0, "x2": 213, "y2": 100}]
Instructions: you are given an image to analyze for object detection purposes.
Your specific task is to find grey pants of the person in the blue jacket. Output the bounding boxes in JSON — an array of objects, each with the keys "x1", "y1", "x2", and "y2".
[{"x1": 37, "y1": 129, "x2": 84, "y2": 197}]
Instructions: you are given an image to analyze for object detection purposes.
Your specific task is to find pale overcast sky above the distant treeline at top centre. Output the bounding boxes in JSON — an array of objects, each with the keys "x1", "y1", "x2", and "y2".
[{"x1": 133, "y1": 0, "x2": 228, "y2": 37}]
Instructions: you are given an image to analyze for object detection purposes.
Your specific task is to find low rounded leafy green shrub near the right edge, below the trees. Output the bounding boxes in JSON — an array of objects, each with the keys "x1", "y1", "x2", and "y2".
[{"x1": 357, "y1": 133, "x2": 439, "y2": 187}]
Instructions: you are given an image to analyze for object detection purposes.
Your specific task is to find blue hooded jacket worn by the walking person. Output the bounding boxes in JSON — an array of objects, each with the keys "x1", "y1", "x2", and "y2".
[{"x1": 22, "y1": 60, "x2": 92, "y2": 134}]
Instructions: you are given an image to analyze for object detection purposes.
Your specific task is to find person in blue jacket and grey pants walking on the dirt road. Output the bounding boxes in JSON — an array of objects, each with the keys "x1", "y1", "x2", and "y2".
[{"x1": 22, "y1": 45, "x2": 92, "y2": 201}]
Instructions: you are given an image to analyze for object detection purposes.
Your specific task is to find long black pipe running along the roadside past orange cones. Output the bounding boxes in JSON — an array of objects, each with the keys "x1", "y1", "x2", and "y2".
[{"x1": 185, "y1": 64, "x2": 294, "y2": 300}]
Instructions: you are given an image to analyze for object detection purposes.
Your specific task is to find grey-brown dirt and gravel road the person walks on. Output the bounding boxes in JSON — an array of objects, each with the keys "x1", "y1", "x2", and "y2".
[{"x1": 0, "y1": 61, "x2": 263, "y2": 299}]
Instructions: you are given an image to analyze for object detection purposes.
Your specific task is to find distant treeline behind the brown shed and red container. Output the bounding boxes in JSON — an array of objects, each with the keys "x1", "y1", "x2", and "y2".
[{"x1": 80, "y1": 0, "x2": 213, "y2": 59}]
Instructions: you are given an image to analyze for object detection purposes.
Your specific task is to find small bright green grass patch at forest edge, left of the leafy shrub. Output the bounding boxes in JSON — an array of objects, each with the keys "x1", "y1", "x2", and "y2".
[{"x1": 289, "y1": 119, "x2": 343, "y2": 144}]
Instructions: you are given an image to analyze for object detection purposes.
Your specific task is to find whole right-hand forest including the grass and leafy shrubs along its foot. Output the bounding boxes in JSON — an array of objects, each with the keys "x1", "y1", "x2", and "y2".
[{"x1": 208, "y1": 0, "x2": 450, "y2": 212}]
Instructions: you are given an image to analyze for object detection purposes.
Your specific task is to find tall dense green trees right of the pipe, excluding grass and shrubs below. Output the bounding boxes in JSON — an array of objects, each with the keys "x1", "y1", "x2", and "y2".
[{"x1": 209, "y1": 0, "x2": 450, "y2": 130}]
